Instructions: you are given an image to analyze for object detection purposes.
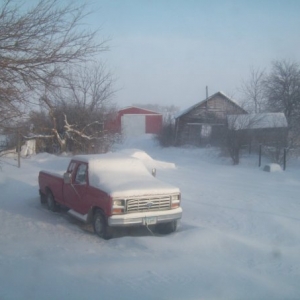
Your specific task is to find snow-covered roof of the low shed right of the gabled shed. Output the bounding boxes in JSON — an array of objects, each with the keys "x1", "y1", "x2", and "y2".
[{"x1": 227, "y1": 113, "x2": 288, "y2": 130}]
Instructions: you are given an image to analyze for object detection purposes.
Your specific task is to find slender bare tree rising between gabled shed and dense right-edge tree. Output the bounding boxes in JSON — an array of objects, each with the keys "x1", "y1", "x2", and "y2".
[{"x1": 241, "y1": 67, "x2": 265, "y2": 113}]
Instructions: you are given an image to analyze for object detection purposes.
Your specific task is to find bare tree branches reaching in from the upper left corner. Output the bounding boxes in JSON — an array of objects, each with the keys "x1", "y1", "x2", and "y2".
[{"x1": 0, "y1": 0, "x2": 107, "y2": 125}]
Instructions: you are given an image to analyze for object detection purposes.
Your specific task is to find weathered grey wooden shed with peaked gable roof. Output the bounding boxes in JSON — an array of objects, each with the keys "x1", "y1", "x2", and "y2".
[{"x1": 175, "y1": 92, "x2": 247, "y2": 146}]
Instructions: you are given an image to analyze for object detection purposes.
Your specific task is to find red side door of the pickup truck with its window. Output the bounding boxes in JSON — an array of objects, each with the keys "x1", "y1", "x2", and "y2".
[{"x1": 63, "y1": 162, "x2": 89, "y2": 214}]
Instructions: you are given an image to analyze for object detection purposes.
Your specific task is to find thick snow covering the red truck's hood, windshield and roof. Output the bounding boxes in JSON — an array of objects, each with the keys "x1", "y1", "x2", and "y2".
[{"x1": 74, "y1": 153, "x2": 180, "y2": 197}]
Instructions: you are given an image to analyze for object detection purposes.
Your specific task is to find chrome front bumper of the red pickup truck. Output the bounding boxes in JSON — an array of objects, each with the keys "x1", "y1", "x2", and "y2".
[{"x1": 108, "y1": 207, "x2": 182, "y2": 226}]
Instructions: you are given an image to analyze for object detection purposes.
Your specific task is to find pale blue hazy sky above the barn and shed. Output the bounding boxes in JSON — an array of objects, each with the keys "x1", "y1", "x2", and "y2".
[{"x1": 90, "y1": 0, "x2": 300, "y2": 109}]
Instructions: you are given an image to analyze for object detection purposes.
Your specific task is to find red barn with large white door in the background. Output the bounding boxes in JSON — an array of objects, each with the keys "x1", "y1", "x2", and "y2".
[{"x1": 105, "y1": 106, "x2": 163, "y2": 136}]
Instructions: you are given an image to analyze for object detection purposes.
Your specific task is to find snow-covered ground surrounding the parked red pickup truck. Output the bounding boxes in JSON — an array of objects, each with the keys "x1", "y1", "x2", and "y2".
[{"x1": 0, "y1": 139, "x2": 300, "y2": 300}]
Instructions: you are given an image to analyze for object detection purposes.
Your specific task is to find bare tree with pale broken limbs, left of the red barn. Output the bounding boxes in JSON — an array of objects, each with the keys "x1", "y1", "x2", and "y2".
[{"x1": 30, "y1": 64, "x2": 115, "y2": 152}]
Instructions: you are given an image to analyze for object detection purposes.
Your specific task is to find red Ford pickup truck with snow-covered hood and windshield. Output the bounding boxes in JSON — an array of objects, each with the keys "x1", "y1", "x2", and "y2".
[{"x1": 38, "y1": 153, "x2": 182, "y2": 239}]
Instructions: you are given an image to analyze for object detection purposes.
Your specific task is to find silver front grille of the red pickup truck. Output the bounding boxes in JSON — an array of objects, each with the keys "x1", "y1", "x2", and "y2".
[{"x1": 126, "y1": 196, "x2": 171, "y2": 213}]
